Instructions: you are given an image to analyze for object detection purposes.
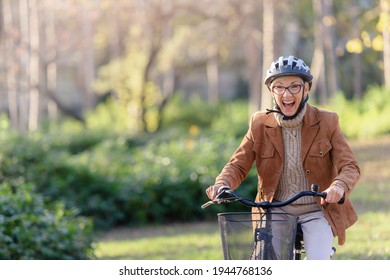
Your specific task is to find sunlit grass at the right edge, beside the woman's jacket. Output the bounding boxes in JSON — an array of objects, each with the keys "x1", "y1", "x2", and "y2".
[{"x1": 330, "y1": 136, "x2": 390, "y2": 260}]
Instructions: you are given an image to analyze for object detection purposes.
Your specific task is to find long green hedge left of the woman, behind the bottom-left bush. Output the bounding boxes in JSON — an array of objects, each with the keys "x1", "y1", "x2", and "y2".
[{"x1": 0, "y1": 97, "x2": 255, "y2": 229}]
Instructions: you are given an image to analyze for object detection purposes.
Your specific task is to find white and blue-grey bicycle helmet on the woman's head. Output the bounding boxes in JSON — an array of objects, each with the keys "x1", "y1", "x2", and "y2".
[{"x1": 264, "y1": 55, "x2": 313, "y2": 87}]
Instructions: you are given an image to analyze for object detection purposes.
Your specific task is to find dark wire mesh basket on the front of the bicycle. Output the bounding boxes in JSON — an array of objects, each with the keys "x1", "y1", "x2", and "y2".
[{"x1": 218, "y1": 212, "x2": 298, "y2": 260}]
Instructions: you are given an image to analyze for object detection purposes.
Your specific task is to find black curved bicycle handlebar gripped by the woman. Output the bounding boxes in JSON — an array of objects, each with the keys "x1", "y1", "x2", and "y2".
[{"x1": 201, "y1": 184, "x2": 344, "y2": 210}]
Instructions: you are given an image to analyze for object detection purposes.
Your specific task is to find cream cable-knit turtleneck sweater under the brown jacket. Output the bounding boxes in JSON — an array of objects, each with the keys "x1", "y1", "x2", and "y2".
[{"x1": 274, "y1": 106, "x2": 320, "y2": 216}]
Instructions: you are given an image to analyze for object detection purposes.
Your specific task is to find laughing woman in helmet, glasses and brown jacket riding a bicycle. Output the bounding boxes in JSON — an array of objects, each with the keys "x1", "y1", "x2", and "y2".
[{"x1": 206, "y1": 56, "x2": 360, "y2": 259}]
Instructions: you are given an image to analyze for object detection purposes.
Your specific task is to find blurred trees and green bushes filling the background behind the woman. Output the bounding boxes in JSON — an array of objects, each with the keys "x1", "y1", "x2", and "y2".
[{"x1": 0, "y1": 0, "x2": 390, "y2": 259}]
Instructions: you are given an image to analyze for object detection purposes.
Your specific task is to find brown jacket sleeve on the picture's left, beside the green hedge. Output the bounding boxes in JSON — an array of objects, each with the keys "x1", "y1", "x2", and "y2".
[{"x1": 215, "y1": 115, "x2": 255, "y2": 189}]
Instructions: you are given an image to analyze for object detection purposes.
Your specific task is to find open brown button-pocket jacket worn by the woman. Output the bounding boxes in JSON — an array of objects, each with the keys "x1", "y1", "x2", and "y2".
[{"x1": 215, "y1": 104, "x2": 360, "y2": 245}]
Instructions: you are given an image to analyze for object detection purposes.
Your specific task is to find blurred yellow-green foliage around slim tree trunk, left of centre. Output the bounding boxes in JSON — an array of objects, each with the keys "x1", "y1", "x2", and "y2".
[{"x1": 93, "y1": 40, "x2": 163, "y2": 131}]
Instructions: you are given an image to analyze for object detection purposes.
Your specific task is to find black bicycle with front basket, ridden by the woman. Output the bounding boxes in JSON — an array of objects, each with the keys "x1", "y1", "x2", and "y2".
[{"x1": 201, "y1": 184, "x2": 344, "y2": 260}]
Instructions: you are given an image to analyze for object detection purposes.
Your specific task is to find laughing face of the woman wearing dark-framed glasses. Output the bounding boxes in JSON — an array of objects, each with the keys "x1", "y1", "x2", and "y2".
[{"x1": 270, "y1": 76, "x2": 309, "y2": 116}]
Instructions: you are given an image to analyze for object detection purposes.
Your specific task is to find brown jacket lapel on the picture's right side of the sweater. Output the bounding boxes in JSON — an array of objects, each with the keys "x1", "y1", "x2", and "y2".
[{"x1": 301, "y1": 104, "x2": 320, "y2": 162}]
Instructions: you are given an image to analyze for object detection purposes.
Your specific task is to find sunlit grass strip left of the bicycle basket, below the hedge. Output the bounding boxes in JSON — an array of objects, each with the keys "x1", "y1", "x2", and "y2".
[{"x1": 96, "y1": 222, "x2": 223, "y2": 260}]
